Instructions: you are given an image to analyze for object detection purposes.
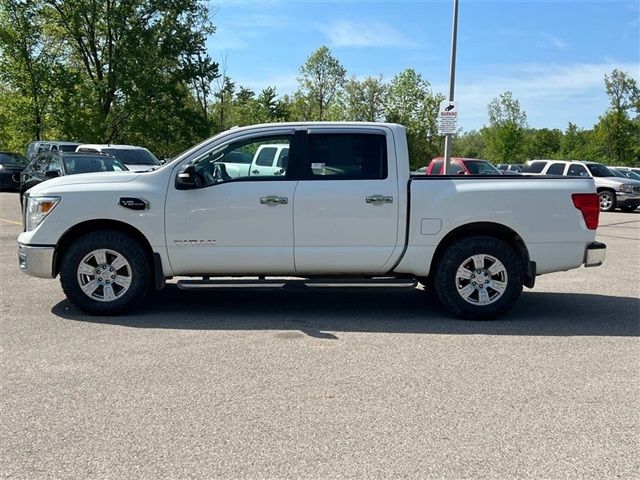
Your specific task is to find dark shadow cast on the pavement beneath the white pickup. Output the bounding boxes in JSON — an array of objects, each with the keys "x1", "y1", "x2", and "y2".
[{"x1": 52, "y1": 284, "x2": 640, "y2": 339}]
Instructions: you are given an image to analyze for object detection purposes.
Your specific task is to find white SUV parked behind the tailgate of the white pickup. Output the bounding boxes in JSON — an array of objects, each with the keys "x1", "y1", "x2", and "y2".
[{"x1": 522, "y1": 160, "x2": 640, "y2": 212}]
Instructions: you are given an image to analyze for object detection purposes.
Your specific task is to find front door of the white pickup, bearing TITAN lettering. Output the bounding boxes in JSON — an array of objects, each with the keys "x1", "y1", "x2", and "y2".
[{"x1": 165, "y1": 135, "x2": 297, "y2": 275}]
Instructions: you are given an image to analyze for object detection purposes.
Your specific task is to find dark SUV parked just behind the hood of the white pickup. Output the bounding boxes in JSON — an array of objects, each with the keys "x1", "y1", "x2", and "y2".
[{"x1": 20, "y1": 151, "x2": 128, "y2": 204}]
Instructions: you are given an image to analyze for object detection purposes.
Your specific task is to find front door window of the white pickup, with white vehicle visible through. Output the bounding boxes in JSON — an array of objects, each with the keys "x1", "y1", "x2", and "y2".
[{"x1": 192, "y1": 136, "x2": 291, "y2": 187}]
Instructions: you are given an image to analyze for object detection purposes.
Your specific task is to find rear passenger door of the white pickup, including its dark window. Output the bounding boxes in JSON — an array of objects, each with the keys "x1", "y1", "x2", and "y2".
[{"x1": 294, "y1": 128, "x2": 399, "y2": 274}]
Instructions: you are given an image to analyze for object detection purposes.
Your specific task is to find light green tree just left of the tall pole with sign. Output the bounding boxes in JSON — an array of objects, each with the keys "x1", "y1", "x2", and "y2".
[{"x1": 385, "y1": 68, "x2": 444, "y2": 169}]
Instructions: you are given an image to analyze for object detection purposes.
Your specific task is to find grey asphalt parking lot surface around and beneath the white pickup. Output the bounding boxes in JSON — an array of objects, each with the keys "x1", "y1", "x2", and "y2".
[{"x1": 0, "y1": 193, "x2": 640, "y2": 479}]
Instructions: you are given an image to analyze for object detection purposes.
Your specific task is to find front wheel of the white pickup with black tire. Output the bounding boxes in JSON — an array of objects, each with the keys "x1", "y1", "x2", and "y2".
[{"x1": 60, "y1": 230, "x2": 153, "y2": 315}]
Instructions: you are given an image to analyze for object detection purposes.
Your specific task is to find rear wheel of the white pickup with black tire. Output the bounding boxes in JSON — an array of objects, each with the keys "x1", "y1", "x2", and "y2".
[{"x1": 433, "y1": 235, "x2": 524, "y2": 320}]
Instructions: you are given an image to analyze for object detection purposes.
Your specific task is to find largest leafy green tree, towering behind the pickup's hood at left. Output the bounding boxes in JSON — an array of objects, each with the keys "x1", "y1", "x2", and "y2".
[{"x1": 44, "y1": 0, "x2": 217, "y2": 141}]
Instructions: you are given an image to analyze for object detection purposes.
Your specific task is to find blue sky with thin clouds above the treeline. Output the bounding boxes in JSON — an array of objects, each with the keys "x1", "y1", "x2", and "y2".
[{"x1": 208, "y1": 0, "x2": 640, "y2": 130}]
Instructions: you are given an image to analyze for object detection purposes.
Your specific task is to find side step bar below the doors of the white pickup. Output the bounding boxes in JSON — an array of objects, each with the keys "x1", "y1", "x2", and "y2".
[{"x1": 177, "y1": 278, "x2": 418, "y2": 290}]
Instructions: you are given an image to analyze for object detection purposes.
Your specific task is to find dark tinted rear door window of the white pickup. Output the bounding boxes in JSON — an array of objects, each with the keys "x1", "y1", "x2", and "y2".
[{"x1": 303, "y1": 133, "x2": 387, "y2": 180}]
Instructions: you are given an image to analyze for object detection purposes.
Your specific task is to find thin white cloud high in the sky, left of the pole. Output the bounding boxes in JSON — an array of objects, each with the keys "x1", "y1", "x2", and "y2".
[{"x1": 319, "y1": 20, "x2": 416, "y2": 47}]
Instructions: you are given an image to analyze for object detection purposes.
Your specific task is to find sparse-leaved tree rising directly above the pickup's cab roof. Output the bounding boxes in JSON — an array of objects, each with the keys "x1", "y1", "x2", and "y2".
[{"x1": 298, "y1": 46, "x2": 347, "y2": 120}]
